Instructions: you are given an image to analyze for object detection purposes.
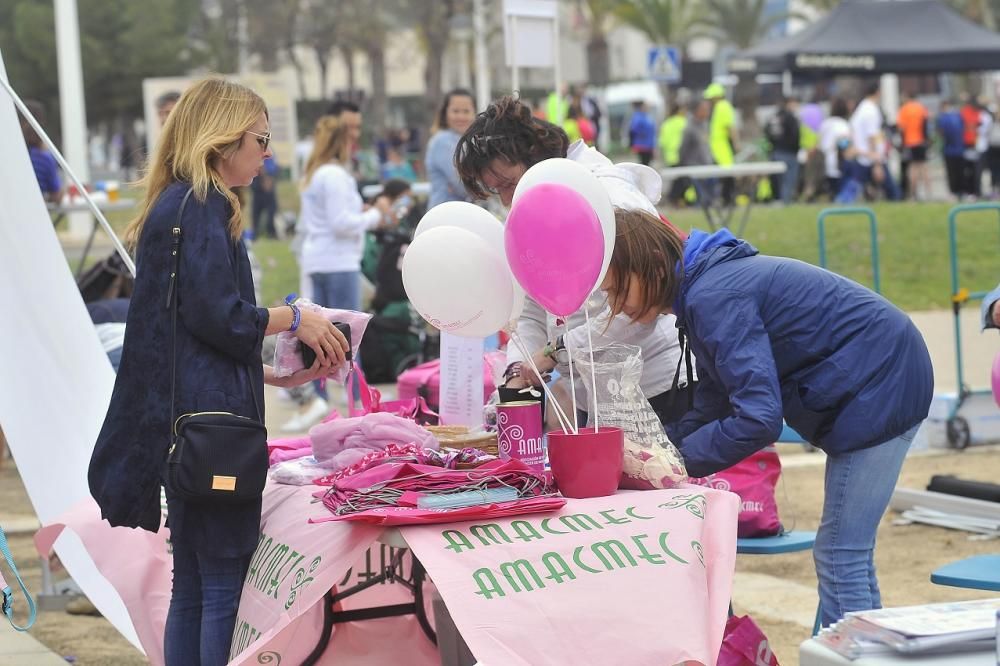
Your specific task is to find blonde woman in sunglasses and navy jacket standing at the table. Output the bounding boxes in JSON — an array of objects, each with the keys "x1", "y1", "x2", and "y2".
[{"x1": 88, "y1": 79, "x2": 347, "y2": 666}]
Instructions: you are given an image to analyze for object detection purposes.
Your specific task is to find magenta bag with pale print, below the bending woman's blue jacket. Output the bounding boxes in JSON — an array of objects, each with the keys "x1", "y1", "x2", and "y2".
[{"x1": 691, "y1": 446, "x2": 781, "y2": 538}]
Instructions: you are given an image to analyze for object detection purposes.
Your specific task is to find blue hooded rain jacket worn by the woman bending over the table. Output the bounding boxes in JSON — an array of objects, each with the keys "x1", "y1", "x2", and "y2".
[{"x1": 668, "y1": 230, "x2": 934, "y2": 477}]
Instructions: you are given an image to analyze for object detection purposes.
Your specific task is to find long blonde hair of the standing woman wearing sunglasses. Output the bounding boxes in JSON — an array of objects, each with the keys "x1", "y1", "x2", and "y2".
[{"x1": 125, "y1": 77, "x2": 267, "y2": 249}]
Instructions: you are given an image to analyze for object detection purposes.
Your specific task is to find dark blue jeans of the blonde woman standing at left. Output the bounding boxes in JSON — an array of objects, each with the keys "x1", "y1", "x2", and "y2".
[{"x1": 163, "y1": 543, "x2": 251, "y2": 666}]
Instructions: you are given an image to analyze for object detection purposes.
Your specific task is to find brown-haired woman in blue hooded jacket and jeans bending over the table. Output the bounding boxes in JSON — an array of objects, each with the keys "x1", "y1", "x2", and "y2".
[{"x1": 602, "y1": 210, "x2": 934, "y2": 625}]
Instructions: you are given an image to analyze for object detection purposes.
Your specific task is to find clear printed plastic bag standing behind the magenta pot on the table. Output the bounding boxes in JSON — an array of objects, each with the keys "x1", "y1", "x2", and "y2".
[{"x1": 573, "y1": 343, "x2": 688, "y2": 490}]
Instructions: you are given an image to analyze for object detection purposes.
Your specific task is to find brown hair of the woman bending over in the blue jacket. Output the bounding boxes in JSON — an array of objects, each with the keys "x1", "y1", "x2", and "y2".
[{"x1": 605, "y1": 208, "x2": 684, "y2": 314}]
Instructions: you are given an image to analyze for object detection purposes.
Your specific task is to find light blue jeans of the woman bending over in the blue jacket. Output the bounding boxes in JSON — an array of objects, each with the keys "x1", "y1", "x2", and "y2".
[{"x1": 813, "y1": 426, "x2": 917, "y2": 626}]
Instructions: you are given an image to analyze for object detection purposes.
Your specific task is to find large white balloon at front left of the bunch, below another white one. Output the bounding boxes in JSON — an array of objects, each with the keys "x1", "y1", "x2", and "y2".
[{"x1": 403, "y1": 226, "x2": 514, "y2": 338}]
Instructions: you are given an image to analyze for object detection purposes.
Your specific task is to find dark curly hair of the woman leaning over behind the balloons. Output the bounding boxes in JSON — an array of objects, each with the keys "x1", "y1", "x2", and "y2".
[{"x1": 455, "y1": 95, "x2": 569, "y2": 199}]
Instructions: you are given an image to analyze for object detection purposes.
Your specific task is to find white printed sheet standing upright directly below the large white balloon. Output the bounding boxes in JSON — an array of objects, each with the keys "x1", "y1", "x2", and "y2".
[{"x1": 438, "y1": 331, "x2": 483, "y2": 428}]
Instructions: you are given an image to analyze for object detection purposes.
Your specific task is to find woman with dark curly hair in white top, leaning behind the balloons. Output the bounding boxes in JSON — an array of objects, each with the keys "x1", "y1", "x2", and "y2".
[{"x1": 455, "y1": 96, "x2": 694, "y2": 423}]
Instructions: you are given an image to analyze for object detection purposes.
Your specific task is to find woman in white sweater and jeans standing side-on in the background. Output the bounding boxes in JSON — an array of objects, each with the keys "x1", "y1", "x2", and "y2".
[{"x1": 299, "y1": 116, "x2": 394, "y2": 408}]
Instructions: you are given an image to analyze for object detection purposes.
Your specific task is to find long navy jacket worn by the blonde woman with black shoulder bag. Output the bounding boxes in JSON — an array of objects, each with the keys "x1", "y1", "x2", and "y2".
[{"x1": 88, "y1": 183, "x2": 268, "y2": 557}]
